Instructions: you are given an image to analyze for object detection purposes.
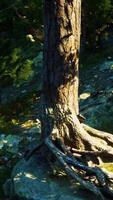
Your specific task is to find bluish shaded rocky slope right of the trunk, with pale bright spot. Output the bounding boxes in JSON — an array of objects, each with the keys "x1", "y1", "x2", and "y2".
[{"x1": 79, "y1": 59, "x2": 113, "y2": 133}]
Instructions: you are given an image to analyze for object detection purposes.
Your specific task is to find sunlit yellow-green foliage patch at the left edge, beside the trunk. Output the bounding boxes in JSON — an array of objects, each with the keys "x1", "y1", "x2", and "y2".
[{"x1": 0, "y1": 48, "x2": 33, "y2": 86}]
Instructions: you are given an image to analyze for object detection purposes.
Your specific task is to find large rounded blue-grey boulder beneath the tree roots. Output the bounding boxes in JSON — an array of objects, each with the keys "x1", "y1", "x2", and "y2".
[{"x1": 4, "y1": 156, "x2": 96, "y2": 200}]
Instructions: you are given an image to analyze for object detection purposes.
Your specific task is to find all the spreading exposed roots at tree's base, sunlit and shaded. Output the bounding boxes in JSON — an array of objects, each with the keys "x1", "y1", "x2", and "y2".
[{"x1": 26, "y1": 121, "x2": 113, "y2": 200}]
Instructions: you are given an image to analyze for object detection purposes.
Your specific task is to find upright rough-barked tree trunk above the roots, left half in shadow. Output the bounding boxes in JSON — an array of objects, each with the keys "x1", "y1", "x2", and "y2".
[{"x1": 42, "y1": 0, "x2": 81, "y2": 146}]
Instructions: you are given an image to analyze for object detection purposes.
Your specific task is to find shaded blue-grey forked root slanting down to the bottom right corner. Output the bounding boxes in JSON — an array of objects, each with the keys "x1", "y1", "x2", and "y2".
[{"x1": 45, "y1": 137, "x2": 113, "y2": 200}]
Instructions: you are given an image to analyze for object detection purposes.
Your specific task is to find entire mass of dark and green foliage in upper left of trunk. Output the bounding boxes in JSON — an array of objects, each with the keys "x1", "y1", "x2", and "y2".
[{"x1": 0, "y1": 0, "x2": 42, "y2": 87}]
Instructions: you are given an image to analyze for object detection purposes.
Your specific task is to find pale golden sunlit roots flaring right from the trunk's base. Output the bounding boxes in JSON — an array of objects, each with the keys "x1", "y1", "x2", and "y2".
[{"x1": 58, "y1": 114, "x2": 113, "y2": 161}]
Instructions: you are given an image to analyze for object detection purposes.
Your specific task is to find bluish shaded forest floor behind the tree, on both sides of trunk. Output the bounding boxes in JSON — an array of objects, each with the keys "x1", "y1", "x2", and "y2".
[{"x1": 0, "y1": 52, "x2": 113, "y2": 199}]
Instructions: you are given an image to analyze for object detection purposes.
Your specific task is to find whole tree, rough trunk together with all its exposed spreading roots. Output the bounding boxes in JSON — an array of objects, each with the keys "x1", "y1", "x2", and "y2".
[{"x1": 27, "y1": 0, "x2": 113, "y2": 200}]
